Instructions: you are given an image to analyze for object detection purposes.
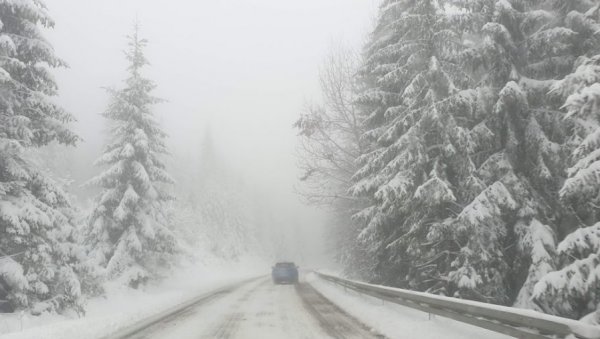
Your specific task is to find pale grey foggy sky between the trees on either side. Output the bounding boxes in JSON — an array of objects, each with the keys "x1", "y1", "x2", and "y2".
[{"x1": 47, "y1": 0, "x2": 376, "y2": 264}]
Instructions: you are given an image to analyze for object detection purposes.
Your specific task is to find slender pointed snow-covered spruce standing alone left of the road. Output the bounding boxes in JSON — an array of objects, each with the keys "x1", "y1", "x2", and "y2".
[{"x1": 87, "y1": 24, "x2": 177, "y2": 288}]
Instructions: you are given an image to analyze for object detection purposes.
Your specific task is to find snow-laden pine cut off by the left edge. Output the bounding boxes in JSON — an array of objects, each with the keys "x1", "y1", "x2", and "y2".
[{"x1": 0, "y1": 0, "x2": 83, "y2": 313}]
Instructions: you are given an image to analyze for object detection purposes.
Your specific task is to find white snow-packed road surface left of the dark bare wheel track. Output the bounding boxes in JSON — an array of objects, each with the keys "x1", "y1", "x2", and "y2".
[{"x1": 126, "y1": 279, "x2": 327, "y2": 339}]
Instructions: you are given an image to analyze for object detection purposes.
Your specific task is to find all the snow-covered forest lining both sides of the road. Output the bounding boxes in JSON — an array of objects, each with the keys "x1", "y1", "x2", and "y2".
[{"x1": 0, "y1": 0, "x2": 600, "y2": 326}]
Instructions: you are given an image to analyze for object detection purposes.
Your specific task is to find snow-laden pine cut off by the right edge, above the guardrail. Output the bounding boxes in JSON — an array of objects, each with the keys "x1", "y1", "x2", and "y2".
[{"x1": 533, "y1": 10, "x2": 600, "y2": 319}]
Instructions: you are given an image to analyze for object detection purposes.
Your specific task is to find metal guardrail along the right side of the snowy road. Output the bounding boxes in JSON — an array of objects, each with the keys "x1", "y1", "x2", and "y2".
[{"x1": 315, "y1": 272, "x2": 600, "y2": 339}]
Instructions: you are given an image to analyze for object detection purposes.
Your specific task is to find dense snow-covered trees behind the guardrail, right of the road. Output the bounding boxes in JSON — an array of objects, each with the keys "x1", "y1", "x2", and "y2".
[{"x1": 295, "y1": 0, "x2": 600, "y2": 319}]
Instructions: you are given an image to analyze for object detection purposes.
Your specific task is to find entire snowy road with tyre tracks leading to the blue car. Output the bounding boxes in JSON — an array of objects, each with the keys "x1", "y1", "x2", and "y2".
[{"x1": 121, "y1": 278, "x2": 383, "y2": 339}]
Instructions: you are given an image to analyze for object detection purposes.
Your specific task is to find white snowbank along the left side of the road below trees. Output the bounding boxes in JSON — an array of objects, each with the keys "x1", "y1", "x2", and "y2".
[{"x1": 0, "y1": 259, "x2": 269, "y2": 339}]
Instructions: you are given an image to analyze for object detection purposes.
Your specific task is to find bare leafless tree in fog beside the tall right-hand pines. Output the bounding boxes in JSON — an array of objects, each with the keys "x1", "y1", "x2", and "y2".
[{"x1": 294, "y1": 44, "x2": 371, "y2": 275}]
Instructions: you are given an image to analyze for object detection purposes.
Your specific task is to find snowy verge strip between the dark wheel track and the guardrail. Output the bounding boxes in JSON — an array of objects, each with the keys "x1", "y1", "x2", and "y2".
[{"x1": 306, "y1": 273, "x2": 511, "y2": 339}]
